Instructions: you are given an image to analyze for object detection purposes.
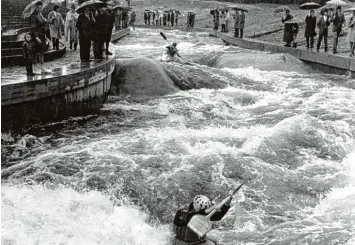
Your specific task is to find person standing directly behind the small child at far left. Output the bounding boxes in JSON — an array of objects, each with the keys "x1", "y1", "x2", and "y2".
[{"x1": 30, "y1": 2, "x2": 49, "y2": 73}]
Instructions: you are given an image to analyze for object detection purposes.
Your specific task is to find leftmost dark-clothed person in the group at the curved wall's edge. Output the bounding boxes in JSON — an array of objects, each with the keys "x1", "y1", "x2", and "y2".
[{"x1": 76, "y1": 8, "x2": 94, "y2": 62}]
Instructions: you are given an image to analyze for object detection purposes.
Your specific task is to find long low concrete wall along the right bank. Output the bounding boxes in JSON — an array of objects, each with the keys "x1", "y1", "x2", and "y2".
[{"x1": 139, "y1": 25, "x2": 355, "y2": 78}]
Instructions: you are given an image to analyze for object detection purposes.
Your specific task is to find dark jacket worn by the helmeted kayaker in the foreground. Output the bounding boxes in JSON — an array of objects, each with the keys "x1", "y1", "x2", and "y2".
[{"x1": 174, "y1": 203, "x2": 230, "y2": 243}]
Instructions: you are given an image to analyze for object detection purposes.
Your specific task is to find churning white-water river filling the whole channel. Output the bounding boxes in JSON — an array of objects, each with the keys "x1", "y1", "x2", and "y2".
[{"x1": 1, "y1": 30, "x2": 355, "y2": 245}]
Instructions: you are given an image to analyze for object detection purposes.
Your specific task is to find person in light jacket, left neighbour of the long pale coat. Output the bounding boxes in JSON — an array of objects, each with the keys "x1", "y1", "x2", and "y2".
[{"x1": 48, "y1": 5, "x2": 64, "y2": 50}]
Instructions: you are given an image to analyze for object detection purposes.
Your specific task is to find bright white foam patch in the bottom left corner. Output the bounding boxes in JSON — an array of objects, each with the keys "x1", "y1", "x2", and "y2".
[{"x1": 1, "y1": 185, "x2": 171, "y2": 245}]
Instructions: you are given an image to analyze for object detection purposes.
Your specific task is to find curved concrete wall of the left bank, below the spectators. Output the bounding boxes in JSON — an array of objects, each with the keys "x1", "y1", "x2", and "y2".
[{"x1": 1, "y1": 30, "x2": 129, "y2": 132}]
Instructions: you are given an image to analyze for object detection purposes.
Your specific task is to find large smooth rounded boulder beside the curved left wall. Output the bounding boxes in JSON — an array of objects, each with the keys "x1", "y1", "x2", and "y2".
[{"x1": 111, "y1": 57, "x2": 179, "y2": 99}]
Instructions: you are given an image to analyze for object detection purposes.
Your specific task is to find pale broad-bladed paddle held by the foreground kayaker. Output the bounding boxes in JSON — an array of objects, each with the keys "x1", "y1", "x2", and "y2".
[{"x1": 187, "y1": 181, "x2": 246, "y2": 237}]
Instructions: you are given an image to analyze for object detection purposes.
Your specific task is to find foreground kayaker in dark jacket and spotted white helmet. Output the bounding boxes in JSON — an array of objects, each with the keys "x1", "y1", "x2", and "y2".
[{"x1": 173, "y1": 195, "x2": 233, "y2": 245}]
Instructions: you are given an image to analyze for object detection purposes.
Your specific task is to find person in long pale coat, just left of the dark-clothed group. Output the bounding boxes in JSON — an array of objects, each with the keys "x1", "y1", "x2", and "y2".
[{"x1": 65, "y1": 4, "x2": 78, "y2": 50}]
